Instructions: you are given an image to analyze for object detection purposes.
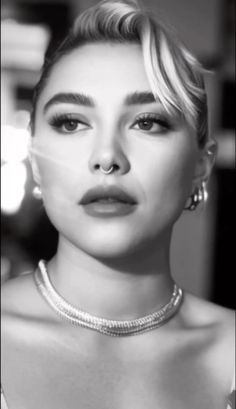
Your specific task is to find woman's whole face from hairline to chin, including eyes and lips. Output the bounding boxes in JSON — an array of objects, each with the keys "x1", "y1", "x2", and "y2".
[{"x1": 32, "y1": 43, "x2": 199, "y2": 258}]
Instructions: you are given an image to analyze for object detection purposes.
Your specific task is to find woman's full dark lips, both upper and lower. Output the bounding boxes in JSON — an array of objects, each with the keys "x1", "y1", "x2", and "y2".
[{"x1": 79, "y1": 186, "x2": 137, "y2": 218}]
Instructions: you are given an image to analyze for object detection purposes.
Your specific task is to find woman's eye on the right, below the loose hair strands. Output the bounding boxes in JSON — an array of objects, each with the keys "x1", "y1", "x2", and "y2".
[{"x1": 132, "y1": 114, "x2": 171, "y2": 133}]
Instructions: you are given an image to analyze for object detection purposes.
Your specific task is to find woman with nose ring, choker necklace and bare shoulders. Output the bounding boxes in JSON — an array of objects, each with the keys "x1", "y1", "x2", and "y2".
[{"x1": 2, "y1": 1, "x2": 234, "y2": 409}]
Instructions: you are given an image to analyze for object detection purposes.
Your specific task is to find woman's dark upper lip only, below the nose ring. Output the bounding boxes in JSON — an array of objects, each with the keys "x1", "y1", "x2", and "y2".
[{"x1": 80, "y1": 186, "x2": 137, "y2": 205}]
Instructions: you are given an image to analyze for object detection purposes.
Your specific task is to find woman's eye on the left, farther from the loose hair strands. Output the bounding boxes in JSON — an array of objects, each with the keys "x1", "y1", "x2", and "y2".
[{"x1": 49, "y1": 114, "x2": 90, "y2": 133}]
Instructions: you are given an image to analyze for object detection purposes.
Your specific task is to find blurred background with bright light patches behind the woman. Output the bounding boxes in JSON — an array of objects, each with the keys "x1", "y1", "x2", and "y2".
[{"x1": 1, "y1": 0, "x2": 235, "y2": 308}]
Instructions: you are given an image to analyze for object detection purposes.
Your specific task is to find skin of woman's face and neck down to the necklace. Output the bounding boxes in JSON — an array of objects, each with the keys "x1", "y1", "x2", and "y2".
[{"x1": 32, "y1": 44, "x2": 206, "y2": 318}]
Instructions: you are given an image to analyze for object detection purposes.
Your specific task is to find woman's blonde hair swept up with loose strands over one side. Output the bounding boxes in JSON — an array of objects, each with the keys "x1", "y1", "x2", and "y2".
[{"x1": 31, "y1": 0, "x2": 208, "y2": 147}]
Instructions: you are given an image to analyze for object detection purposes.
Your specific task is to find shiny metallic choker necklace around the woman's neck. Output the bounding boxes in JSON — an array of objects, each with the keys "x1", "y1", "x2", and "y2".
[{"x1": 34, "y1": 260, "x2": 183, "y2": 337}]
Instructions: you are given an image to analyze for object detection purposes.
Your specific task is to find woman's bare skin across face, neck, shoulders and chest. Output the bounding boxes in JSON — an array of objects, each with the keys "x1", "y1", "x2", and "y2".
[{"x1": 3, "y1": 44, "x2": 233, "y2": 409}]
